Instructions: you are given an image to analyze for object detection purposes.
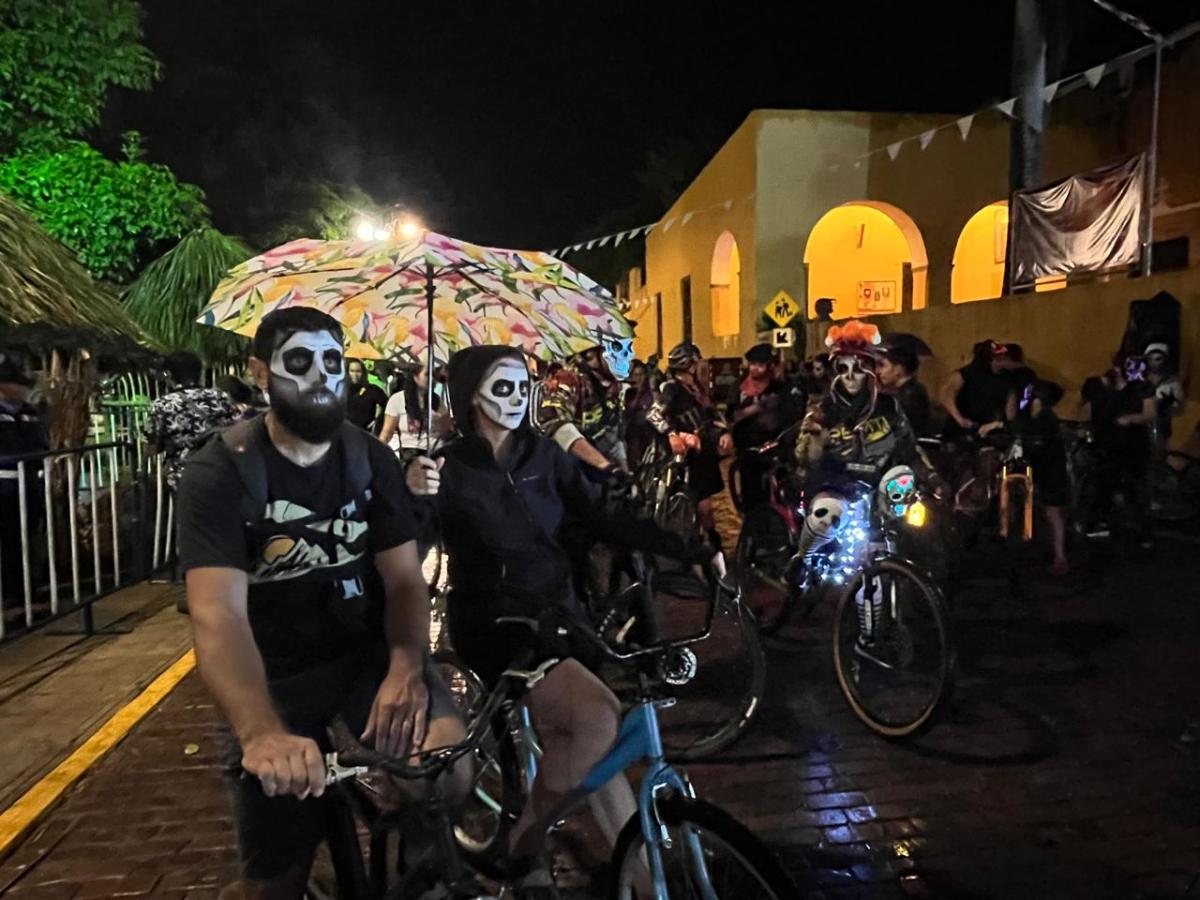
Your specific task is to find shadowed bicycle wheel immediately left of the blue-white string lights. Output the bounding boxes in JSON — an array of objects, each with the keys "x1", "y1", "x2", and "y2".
[{"x1": 734, "y1": 506, "x2": 796, "y2": 634}]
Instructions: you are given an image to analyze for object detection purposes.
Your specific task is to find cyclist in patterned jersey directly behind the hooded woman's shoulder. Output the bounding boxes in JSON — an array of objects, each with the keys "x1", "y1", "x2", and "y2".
[{"x1": 536, "y1": 336, "x2": 632, "y2": 469}]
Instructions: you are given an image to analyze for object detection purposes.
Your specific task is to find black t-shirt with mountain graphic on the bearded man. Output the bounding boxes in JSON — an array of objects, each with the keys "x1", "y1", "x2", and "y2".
[{"x1": 179, "y1": 429, "x2": 416, "y2": 679}]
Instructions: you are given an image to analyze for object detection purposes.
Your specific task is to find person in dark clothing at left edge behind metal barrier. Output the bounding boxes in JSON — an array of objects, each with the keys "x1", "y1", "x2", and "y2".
[{"x1": 0, "y1": 350, "x2": 49, "y2": 608}]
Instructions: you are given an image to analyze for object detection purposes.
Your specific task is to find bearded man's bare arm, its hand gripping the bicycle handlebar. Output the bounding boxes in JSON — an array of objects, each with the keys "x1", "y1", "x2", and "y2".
[{"x1": 187, "y1": 566, "x2": 325, "y2": 799}]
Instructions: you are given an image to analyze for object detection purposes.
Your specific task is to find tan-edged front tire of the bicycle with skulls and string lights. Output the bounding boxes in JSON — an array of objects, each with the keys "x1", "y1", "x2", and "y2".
[{"x1": 833, "y1": 559, "x2": 955, "y2": 738}]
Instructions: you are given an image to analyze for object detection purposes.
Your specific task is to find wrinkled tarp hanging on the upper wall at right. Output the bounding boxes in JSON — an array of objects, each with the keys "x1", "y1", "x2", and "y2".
[{"x1": 1009, "y1": 154, "x2": 1146, "y2": 287}]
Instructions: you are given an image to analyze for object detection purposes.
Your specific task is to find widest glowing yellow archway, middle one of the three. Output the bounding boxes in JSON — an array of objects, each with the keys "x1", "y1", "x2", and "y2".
[{"x1": 804, "y1": 200, "x2": 929, "y2": 319}]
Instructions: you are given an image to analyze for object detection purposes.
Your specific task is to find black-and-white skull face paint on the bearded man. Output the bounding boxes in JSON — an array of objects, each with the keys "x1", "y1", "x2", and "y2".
[{"x1": 268, "y1": 331, "x2": 346, "y2": 444}]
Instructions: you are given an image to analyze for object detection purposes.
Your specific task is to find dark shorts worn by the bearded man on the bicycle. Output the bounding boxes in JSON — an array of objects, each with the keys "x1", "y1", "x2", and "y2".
[{"x1": 226, "y1": 654, "x2": 456, "y2": 881}]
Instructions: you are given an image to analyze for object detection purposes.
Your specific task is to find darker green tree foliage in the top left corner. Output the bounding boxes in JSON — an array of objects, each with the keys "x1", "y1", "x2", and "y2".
[{"x1": 0, "y1": 0, "x2": 160, "y2": 152}]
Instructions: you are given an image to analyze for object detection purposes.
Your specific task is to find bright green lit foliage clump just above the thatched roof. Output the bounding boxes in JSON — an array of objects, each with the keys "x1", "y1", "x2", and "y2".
[{"x1": 0, "y1": 133, "x2": 209, "y2": 282}]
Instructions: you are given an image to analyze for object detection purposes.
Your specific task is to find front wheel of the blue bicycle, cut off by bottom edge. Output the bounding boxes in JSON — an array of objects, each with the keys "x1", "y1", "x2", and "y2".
[{"x1": 608, "y1": 797, "x2": 800, "y2": 900}]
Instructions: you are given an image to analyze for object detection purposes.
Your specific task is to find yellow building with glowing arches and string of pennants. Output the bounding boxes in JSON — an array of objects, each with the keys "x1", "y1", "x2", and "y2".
[{"x1": 622, "y1": 35, "x2": 1200, "y2": 367}]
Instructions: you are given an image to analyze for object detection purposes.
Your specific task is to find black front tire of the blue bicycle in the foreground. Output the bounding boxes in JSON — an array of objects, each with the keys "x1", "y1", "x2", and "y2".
[{"x1": 607, "y1": 796, "x2": 800, "y2": 900}]
